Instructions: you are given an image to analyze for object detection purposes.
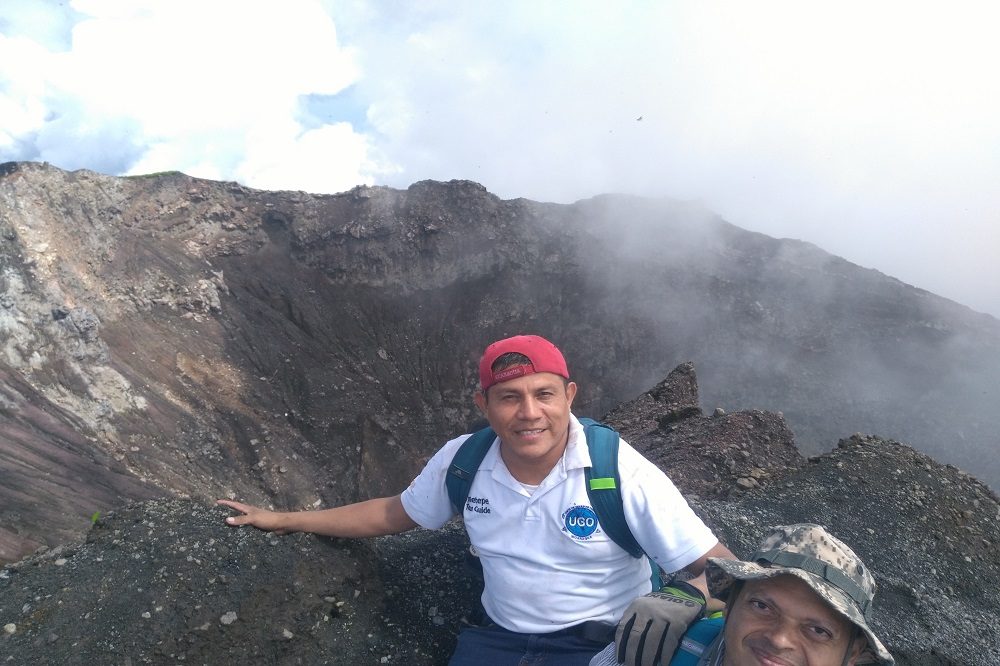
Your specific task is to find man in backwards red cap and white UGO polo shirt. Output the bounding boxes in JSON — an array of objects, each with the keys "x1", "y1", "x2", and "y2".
[{"x1": 219, "y1": 335, "x2": 735, "y2": 666}]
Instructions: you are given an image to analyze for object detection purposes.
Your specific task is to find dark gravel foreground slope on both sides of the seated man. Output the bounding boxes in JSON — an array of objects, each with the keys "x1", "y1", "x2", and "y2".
[{"x1": 0, "y1": 366, "x2": 1000, "y2": 666}]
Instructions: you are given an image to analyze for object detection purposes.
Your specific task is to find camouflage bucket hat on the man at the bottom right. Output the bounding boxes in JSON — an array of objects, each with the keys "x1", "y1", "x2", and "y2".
[{"x1": 705, "y1": 523, "x2": 895, "y2": 664}]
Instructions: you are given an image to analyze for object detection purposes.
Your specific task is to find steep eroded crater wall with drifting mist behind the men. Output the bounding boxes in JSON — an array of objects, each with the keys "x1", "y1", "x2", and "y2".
[{"x1": 0, "y1": 163, "x2": 1000, "y2": 560}]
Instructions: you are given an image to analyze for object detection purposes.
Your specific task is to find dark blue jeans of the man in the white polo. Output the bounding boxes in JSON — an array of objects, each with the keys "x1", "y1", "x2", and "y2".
[{"x1": 448, "y1": 624, "x2": 608, "y2": 666}]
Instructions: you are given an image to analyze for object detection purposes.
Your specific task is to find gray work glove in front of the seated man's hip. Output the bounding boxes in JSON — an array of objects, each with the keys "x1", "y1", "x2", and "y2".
[{"x1": 615, "y1": 581, "x2": 705, "y2": 666}]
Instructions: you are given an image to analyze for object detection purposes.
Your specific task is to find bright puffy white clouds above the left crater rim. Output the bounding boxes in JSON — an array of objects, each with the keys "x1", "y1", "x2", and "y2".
[{"x1": 0, "y1": 0, "x2": 382, "y2": 191}]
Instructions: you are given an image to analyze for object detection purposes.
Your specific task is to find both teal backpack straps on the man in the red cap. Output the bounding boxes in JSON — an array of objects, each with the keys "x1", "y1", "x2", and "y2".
[{"x1": 444, "y1": 418, "x2": 644, "y2": 556}]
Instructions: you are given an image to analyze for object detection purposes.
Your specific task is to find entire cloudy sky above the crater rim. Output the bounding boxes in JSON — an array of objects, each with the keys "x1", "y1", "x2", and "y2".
[{"x1": 0, "y1": 0, "x2": 1000, "y2": 317}]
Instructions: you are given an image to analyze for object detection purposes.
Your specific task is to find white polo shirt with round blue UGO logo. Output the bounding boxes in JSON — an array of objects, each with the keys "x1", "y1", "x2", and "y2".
[{"x1": 402, "y1": 415, "x2": 718, "y2": 634}]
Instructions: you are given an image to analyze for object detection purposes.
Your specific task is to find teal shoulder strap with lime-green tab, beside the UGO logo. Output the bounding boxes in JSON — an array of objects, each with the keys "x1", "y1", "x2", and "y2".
[{"x1": 580, "y1": 418, "x2": 643, "y2": 557}]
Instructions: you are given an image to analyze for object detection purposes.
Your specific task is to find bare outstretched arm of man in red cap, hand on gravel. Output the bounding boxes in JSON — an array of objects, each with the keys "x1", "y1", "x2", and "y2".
[{"x1": 216, "y1": 495, "x2": 417, "y2": 537}]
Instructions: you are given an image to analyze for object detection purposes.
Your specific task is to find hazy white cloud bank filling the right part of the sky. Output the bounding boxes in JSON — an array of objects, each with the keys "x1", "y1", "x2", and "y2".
[{"x1": 330, "y1": 1, "x2": 1000, "y2": 314}]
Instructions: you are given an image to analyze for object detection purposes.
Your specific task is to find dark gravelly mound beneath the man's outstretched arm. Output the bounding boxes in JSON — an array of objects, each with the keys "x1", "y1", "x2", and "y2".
[{"x1": 0, "y1": 500, "x2": 480, "y2": 666}]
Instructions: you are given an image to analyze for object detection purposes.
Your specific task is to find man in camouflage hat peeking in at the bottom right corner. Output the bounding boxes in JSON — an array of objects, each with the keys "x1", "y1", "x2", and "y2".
[{"x1": 700, "y1": 523, "x2": 895, "y2": 666}]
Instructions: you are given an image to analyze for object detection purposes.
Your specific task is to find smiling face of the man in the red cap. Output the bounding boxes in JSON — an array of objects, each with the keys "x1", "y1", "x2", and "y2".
[{"x1": 476, "y1": 372, "x2": 576, "y2": 484}]
